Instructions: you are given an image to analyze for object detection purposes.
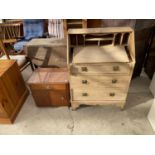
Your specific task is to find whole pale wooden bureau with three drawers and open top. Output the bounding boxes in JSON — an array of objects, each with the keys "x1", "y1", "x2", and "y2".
[{"x1": 67, "y1": 27, "x2": 135, "y2": 109}]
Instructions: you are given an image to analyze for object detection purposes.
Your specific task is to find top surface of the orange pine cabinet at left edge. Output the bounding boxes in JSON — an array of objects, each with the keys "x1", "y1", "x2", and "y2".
[{"x1": 0, "y1": 60, "x2": 15, "y2": 76}]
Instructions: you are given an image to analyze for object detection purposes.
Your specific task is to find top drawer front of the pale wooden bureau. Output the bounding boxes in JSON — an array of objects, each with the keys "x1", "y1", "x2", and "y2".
[{"x1": 71, "y1": 63, "x2": 131, "y2": 74}]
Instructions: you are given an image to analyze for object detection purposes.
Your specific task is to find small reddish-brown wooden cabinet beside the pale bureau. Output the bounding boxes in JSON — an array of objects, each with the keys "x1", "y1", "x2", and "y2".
[{"x1": 28, "y1": 68, "x2": 70, "y2": 106}]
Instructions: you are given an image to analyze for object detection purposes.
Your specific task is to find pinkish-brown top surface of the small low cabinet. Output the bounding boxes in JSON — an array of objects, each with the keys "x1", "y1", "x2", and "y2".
[{"x1": 28, "y1": 68, "x2": 69, "y2": 84}]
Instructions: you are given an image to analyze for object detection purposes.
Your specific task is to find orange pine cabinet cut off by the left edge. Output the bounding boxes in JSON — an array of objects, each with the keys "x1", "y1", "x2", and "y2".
[{"x1": 0, "y1": 60, "x2": 28, "y2": 123}]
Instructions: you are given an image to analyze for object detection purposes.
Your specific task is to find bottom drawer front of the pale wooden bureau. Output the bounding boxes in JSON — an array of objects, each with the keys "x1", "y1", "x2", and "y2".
[{"x1": 71, "y1": 88, "x2": 127, "y2": 101}]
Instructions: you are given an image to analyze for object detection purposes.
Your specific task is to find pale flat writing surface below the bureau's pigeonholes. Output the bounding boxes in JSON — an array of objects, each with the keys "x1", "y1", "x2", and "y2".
[{"x1": 73, "y1": 46, "x2": 129, "y2": 63}]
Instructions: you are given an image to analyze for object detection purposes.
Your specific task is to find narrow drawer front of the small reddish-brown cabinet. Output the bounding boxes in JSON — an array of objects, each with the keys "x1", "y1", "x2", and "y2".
[{"x1": 30, "y1": 84, "x2": 66, "y2": 90}]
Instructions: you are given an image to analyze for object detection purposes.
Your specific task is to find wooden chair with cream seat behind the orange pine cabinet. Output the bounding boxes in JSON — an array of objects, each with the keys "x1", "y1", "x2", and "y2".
[{"x1": 0, "y1": 39, "x2": 34, "y2": 71}]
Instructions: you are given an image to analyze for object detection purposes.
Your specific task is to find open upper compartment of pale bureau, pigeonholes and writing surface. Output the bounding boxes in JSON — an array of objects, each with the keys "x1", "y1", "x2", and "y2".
[{"x1": 68, "y1": 31, "x2": 132, "y2": 63}]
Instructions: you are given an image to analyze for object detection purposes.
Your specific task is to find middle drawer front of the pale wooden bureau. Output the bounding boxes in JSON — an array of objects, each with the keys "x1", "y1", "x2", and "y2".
[{"x1": 70, "y1": 75, "x2": 130, "y2": 90}]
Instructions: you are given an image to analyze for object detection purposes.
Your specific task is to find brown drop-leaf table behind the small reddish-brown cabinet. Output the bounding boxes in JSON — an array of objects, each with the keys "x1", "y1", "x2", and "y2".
[{"x1": 24, "y1": 38, "x2": 67, "y2": 67}]
